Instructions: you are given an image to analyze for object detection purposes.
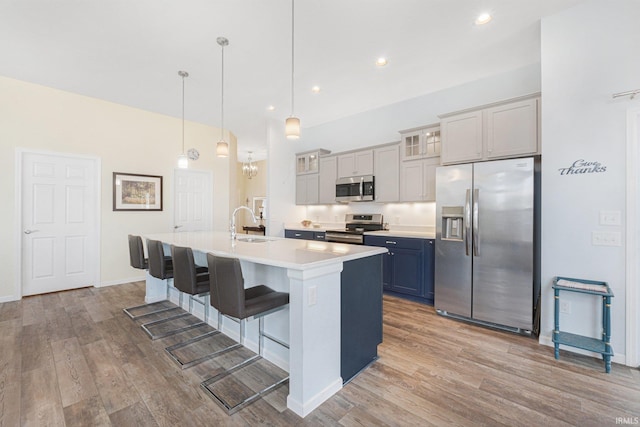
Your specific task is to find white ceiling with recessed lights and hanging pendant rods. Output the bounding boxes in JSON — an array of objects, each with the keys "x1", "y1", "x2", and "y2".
[{"x1": 0, "y1": 0, "x2": 583, "y2": 159}]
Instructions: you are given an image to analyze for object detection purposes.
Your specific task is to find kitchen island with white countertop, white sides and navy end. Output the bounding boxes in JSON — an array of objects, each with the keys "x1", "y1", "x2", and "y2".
[{"x1": 144, "y1": 232, "x2": 387, "y2": 417}]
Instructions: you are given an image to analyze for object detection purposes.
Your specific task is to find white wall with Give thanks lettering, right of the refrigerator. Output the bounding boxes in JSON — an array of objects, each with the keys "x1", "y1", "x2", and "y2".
[{"x1": 541, "y1": 0, "x2": 640, "y2": 362}]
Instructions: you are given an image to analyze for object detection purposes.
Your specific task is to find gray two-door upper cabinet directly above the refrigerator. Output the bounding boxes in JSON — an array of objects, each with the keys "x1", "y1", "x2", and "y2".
[{"x1": 440, "y1": 94, "x2": 540, "y2": 164}]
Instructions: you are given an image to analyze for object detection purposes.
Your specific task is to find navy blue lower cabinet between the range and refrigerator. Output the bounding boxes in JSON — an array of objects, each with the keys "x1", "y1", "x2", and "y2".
[{"x1": 364, "y1": 235, "x2": 435, "y2": 304}]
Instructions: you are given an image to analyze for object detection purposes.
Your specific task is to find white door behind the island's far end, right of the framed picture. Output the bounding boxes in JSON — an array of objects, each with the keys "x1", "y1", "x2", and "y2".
[{"x1": 173, "y1": 169, "x2": 213, "y2": 231}]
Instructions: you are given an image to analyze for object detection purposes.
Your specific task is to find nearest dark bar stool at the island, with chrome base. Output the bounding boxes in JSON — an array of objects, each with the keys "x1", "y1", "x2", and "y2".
[{"x1": 200, "y1": 253, "x2": 289, "y2": 414}]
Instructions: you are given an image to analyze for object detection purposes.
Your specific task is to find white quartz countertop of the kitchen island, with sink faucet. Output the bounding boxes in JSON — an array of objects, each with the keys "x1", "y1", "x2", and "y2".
[{"x1": 144, "y1": 231, "x2": 387, "y2": 270}]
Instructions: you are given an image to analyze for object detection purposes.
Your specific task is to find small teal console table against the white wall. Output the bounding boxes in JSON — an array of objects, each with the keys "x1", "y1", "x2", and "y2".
[{"x1": 553, "y1": 277, "x2": 613, "y2": 373}]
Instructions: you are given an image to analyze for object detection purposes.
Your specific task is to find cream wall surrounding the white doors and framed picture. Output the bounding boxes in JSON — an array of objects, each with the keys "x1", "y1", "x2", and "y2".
[{"x1": 0, "y1": 77, "x2": 235, "y2": 301}]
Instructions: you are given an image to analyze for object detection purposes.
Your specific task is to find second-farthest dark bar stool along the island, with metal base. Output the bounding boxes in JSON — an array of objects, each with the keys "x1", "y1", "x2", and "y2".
[{"x1": 142, "y1": 239, "x2": 190, "y2": 340}]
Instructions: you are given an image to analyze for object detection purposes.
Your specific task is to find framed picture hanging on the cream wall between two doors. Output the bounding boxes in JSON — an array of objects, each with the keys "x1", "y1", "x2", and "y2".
[{"x1": 113, "y1": 172, "x2": 162, "y2": 211}]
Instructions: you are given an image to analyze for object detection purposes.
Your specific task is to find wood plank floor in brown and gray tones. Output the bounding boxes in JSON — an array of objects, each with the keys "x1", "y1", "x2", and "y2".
[{"x1": 0, "y1": 282, "x2": 640, "y2": 426}]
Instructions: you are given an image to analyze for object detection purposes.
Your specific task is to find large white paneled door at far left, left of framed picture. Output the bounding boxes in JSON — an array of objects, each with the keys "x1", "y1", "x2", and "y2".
[{"x1": 21, "y1": 153, "x2": 99, "y2": 295}]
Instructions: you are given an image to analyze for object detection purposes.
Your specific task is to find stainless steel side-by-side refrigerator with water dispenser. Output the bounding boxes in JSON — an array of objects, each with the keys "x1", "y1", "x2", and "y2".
[{"x1": 434, "y1": 158, "x2": 540, "y2": 333}]
